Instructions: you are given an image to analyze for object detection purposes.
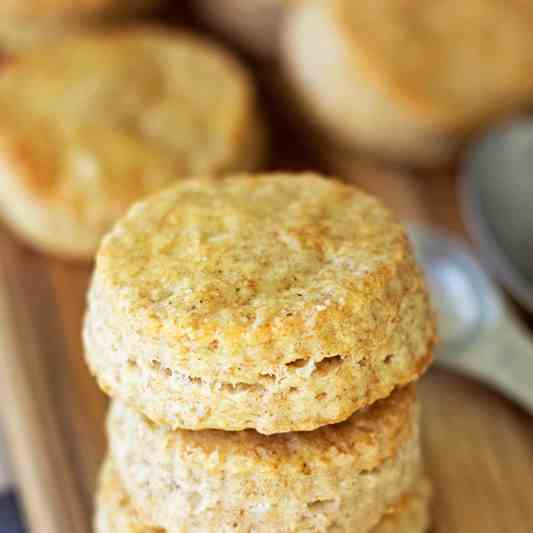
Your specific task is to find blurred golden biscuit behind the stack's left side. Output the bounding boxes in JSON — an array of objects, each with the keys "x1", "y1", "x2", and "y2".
[{"x1": 0, "y1": 28, "x2": 265, "y2": 259}]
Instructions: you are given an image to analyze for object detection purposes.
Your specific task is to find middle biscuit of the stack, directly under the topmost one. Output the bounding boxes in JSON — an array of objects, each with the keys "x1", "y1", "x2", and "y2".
[{"x1": 107, "y1": 387, "x2": 421, "y2": 533}]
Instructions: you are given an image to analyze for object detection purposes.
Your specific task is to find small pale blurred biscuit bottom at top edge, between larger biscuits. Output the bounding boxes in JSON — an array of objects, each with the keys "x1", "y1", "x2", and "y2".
[{"x1": 196, "y1": 0, "x2": 302, "y2": 57}]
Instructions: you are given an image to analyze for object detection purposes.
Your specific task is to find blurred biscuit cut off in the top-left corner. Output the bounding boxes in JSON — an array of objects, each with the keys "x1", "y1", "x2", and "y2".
[{"x1": 0, "y1": 0, "x2": 164, "y2": 54}]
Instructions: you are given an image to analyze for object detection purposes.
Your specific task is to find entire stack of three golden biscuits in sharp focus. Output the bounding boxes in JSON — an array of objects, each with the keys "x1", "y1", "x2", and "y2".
[{"x1": 84, "y1": 174, "x2": 435, "y2": 533}]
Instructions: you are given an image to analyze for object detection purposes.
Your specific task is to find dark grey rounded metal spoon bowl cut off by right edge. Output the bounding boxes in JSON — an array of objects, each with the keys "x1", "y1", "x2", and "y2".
[{"x1": 460, "y1": 118, "x2": 533, "y2": 313}]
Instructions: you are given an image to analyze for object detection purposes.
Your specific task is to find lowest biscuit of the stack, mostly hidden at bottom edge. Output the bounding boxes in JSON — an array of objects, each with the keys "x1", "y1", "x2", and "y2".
[{"x1": 94, "y1": 459, "x2": 429, "y2": 533}]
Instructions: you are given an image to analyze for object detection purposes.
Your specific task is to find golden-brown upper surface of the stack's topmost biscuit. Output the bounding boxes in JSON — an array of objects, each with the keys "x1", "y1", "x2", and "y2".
[{"x1": 92, "y1": 174, "x2": 429, "y2": 379}]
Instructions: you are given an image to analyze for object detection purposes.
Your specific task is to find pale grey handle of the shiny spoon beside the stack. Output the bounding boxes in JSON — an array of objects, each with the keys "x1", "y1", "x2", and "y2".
[{"x1": 446, "y1": 313, "x2": 533, "y2": 413}]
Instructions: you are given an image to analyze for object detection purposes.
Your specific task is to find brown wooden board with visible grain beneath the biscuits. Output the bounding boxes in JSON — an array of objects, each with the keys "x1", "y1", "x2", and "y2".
[{"x1": 0, "y1": 8, "x2": 533, "y2": 533}]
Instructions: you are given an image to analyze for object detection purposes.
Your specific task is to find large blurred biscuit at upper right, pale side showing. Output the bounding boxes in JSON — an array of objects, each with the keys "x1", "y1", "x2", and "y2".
[{"x1": 282, "y1": 0, "x2": 533, "y2": 167}]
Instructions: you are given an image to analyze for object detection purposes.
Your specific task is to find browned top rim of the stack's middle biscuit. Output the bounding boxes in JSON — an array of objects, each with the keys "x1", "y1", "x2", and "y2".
[{"x1": 108, "y1": 386, "x2": 418, "y2": 476}]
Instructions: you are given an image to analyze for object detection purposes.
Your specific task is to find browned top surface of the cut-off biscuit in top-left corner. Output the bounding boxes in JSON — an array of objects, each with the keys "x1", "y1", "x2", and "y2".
[{"x1": 0, "y1": 0, "x2": 155, "y2": 17}]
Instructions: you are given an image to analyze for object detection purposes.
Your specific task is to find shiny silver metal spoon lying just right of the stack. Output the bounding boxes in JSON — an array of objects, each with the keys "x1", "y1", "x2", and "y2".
[{"x1": 410, "y1": 227, "x2": 533, "y2": 413}]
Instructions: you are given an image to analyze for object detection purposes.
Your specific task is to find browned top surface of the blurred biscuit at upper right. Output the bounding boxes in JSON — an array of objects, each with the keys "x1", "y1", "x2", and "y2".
[{"x1": 332, "y1": 0, "x2": 533, "y2": 126}]
